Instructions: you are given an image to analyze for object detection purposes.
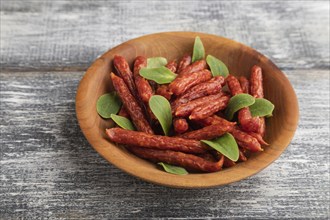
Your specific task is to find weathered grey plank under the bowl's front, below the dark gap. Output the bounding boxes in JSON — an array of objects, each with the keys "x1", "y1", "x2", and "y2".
[{"x1": 0, "y1": 70, "x2": 330, "y2": 219}]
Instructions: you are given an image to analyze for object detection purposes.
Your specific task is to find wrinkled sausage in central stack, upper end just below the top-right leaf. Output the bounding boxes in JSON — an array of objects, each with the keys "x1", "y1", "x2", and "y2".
[{"x1": 171, "y1": 76, "x2": 225, "y2": 109}]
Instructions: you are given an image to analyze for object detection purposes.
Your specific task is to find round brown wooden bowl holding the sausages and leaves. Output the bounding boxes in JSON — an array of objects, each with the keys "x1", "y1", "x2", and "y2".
[{"x1": 76, "y1": 32, "x2": 299, "y2": 188}]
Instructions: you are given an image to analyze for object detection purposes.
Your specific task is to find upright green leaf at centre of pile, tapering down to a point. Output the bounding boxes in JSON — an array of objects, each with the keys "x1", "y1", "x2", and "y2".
[{"x1": 149, "y1": 95, "x2": 172, "y2": 136}]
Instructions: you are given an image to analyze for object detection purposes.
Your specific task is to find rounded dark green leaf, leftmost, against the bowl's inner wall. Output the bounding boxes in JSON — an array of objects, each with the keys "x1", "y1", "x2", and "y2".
[{"x1": 96, "y1": 92, "x2": 121, "y2": 119}]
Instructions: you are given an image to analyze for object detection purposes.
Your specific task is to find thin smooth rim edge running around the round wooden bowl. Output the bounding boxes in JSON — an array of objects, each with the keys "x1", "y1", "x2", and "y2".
[{"x1": 75, "y1": 31, "x2": 299, "y2": 189}]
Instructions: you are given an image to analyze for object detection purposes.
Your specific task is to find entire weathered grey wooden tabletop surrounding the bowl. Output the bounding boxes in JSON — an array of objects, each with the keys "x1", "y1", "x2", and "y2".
[{"x1": 0, "y1": 0, "x2": 330, "y2": 219}]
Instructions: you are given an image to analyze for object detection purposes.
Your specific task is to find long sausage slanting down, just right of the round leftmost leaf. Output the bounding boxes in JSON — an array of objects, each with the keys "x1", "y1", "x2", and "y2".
[{"x1": 111, "y1": 73, "x2": 154, "y2": 134}]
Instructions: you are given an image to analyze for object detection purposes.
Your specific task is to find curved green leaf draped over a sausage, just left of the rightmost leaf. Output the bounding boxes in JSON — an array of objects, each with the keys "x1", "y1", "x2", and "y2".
[{"x1": 225, "y1": 93, "x2": 255, "y2": 120}]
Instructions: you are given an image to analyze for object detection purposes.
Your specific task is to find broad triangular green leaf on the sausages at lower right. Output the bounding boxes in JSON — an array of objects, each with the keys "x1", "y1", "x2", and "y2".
[{"x1": 201, "y1": 133, "x2": 239, "y2": 161}]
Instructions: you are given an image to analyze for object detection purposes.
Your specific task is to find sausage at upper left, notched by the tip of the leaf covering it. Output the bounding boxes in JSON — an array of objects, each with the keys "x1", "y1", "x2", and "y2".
[{"x1": 133, "y1": 56, "x2": 153, "y2": 103}]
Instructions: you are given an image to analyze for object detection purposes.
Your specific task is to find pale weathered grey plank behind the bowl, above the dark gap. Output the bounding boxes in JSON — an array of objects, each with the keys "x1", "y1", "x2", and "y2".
[{"x1": 0, "y1": 0, "x2": 329, "y2": 71}]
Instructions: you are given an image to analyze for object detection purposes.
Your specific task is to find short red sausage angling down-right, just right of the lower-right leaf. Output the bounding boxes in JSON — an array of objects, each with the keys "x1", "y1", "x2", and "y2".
[{"x1": 231, "y1": 129, "x2": 263, "y2": 152}]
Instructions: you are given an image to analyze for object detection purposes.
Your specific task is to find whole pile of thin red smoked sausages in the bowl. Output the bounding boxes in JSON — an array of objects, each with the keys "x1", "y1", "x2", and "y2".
[{"x1": 106, "y1": 55, "x2": 267, "y2": 172}]
